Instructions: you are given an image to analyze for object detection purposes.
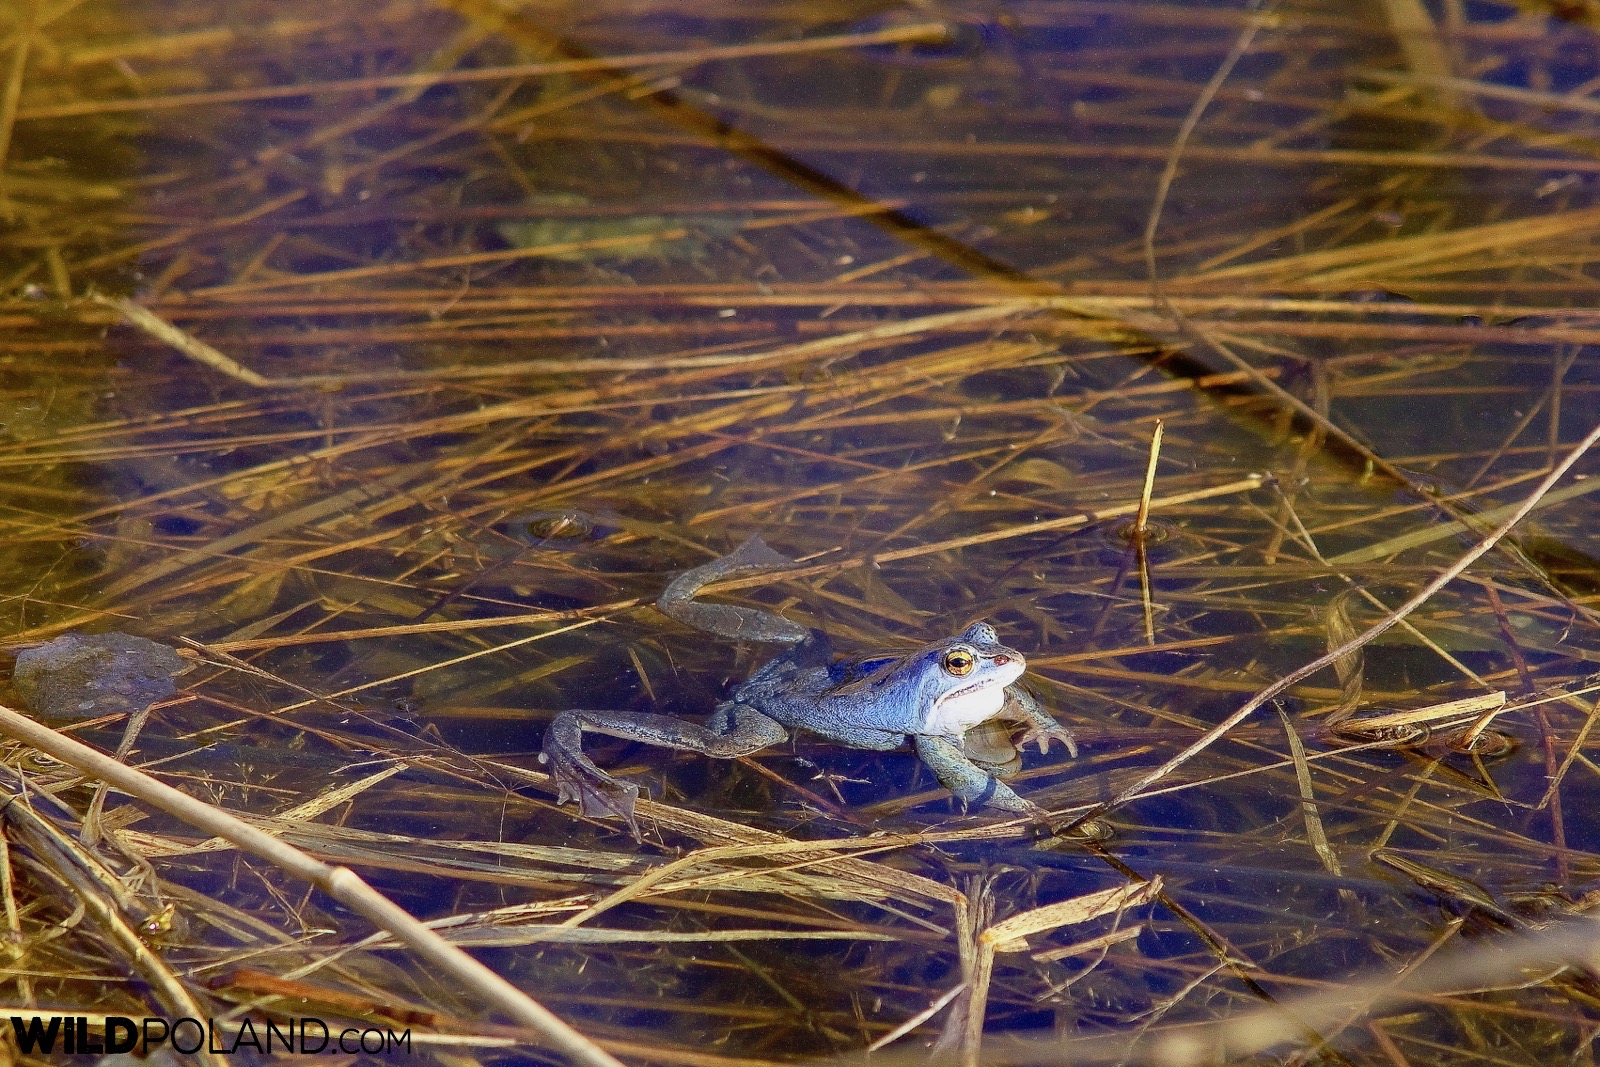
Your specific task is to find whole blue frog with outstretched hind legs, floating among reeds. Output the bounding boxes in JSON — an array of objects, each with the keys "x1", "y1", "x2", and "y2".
[{"x1": 539, "y1": 537, "x2": 1077, "y2": 835}]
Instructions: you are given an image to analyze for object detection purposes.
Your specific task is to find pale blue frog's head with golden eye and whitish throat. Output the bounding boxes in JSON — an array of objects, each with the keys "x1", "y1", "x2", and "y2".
[{"x1": 912, "y1": 622, "x2": 1027, "y2": 736}]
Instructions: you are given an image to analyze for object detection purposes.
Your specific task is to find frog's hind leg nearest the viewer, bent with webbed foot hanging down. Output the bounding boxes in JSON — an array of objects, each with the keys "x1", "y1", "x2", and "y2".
[{"x1": 539, "y1": 704, "x2": 789, "y2": 837}]
